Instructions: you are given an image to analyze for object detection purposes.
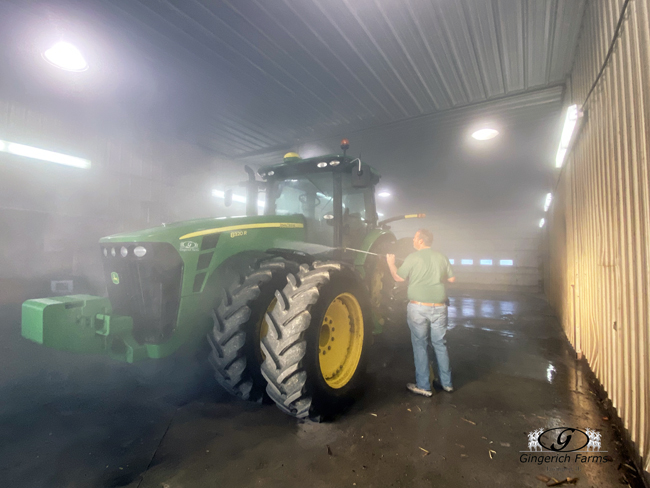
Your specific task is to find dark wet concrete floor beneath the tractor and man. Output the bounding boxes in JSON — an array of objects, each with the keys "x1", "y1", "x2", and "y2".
[{"x1": 0, "y1": 291, "x2": 627, "y2": 488}]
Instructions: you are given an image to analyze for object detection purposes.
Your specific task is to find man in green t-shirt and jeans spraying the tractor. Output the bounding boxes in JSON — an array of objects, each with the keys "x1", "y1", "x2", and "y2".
[{"x1": 386, "y1": 229, "x2": 455, "y2": 397}]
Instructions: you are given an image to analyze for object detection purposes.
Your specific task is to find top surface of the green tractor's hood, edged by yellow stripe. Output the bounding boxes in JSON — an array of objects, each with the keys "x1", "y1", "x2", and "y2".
[{"x1": 99, "y1": 215, "x2": 304, "y2": 247}]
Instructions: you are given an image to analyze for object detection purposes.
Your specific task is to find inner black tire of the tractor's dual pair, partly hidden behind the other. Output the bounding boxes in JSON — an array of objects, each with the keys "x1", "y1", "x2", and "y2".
[{"x1": 208, "y1": 253, "x2": 298, "y2": 401}]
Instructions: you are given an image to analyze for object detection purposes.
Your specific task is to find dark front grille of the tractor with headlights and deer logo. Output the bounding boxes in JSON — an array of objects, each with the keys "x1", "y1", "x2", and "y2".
[{"x1": 101, "y1": 242, "x2": 183, "y2": 344}]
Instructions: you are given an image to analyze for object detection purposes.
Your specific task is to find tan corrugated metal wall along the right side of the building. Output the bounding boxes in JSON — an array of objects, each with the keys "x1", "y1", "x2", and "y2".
[{"x1": 546, "y1": 0, "x2": 650, "y2": 471}]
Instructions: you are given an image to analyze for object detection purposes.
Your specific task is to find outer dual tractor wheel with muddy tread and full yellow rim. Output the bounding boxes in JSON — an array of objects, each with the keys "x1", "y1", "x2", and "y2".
[{"x1": 261, "y1": 262, "x2": 372, "y2": 420}]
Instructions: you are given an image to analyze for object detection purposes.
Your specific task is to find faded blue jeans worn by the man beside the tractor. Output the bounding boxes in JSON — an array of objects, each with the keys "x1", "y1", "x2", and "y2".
[{"x1": 406, "y1": 303, "x2": 452, "y2": 390}]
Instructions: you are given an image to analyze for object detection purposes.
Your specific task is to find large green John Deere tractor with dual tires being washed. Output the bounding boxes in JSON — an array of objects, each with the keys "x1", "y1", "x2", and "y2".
[{"x1": 22, "y1": 141, "x2": 423, "y2": 419}]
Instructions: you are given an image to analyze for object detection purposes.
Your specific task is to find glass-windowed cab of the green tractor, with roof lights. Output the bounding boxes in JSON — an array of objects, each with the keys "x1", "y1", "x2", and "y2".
[{"x1": 256, "y1": 145, "x2": 380, "y2": 252}]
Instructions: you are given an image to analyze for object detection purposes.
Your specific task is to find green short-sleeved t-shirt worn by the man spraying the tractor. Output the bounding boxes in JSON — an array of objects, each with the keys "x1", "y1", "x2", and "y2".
[{"x1": 397, "y1": 248, "x2": 454, "y2": 303}]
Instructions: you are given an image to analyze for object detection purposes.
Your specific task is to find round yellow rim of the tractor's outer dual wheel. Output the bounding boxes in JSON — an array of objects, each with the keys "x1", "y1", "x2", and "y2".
[{"x1": 318, "y1": 293, "x2": 363, "y2": 389}]
